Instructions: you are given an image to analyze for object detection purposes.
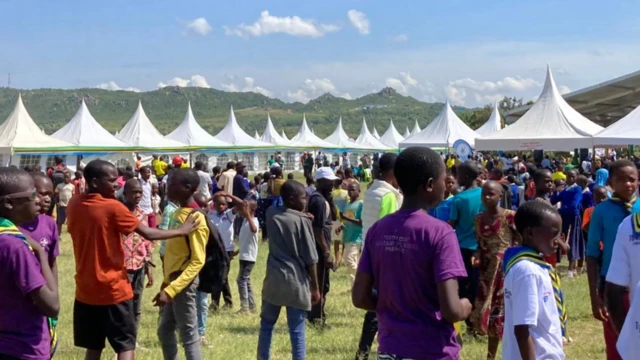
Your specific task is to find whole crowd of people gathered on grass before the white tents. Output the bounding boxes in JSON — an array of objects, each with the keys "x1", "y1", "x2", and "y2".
[{"x1": 0, "y1": 147, "x2": 640, "y2": 360}]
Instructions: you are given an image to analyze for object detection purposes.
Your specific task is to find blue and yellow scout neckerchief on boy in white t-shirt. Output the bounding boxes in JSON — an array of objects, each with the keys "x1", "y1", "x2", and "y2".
[{"x1": 503, "y1": 246, "x2": 567, "y2": 337}]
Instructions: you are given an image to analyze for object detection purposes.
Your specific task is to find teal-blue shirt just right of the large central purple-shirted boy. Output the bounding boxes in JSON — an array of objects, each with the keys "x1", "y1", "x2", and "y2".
[{"x1": 449, "y1": 187, "x2": 485, "y2": 250}]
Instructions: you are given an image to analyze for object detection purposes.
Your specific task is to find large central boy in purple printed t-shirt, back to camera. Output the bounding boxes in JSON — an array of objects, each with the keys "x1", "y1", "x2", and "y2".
[{"x1": 352, "y1": 147, "x2": 471, "y2": 360}]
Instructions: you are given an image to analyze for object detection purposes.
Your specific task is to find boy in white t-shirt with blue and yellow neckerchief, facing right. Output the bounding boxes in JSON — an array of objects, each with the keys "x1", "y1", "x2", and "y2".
[{"x1": 502, "y1": 201, "x2": 566, "y2": 360}]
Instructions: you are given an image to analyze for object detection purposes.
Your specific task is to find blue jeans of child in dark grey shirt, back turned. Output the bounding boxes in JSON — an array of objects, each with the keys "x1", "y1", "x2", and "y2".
[{"x1": 258, "y1": 300, "x2": 307, "y2": 360}]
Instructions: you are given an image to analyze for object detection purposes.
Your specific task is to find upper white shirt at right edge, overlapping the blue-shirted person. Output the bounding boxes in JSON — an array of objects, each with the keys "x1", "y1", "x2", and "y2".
[{"x1": 607, "y1": 216, "x2": 640, "y2": 301}]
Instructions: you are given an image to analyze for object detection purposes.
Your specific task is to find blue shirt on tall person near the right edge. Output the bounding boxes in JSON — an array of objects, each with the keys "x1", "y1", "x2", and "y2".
[{"x1": 587, "y1": 200, "x2": 640, "y2": 276}]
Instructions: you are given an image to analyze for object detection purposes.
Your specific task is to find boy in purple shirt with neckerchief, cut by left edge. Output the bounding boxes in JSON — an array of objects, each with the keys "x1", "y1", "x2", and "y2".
[{"x1": 0, "y1": 168, "x2": 60, "y2": 360}]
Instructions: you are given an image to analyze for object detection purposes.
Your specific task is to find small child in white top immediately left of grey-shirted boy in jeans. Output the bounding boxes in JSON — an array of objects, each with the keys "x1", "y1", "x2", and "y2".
[{"x1": 236, "y1": 200, "x2": 260, "y2": 314}]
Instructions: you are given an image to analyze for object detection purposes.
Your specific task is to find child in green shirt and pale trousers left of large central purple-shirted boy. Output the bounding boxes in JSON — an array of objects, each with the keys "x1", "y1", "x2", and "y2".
[{"x1": 339, "y1": 183, "x2": 363, "y2": 286}]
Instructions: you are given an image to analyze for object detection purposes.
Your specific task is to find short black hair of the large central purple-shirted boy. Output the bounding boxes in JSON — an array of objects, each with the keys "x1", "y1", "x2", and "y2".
[{"x1": 393, "y1": 146, "x2": 444, "y2": 195}]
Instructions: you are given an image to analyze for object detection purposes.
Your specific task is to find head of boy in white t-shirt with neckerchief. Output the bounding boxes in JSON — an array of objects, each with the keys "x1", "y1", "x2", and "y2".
[{"x1": 514, "y1": 201, "x2": 562, "y2": 255}]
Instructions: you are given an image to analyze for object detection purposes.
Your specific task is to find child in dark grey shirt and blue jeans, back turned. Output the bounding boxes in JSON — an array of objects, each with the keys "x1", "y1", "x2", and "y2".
[{"x1": 258, "y1": 180, "x2": 320, "y2": 360}]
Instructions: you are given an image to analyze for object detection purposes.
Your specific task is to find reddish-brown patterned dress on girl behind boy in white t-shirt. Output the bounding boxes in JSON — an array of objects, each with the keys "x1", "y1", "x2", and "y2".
[{"x1": 471, "y1": 210, "x2": 520, "y2": 338}]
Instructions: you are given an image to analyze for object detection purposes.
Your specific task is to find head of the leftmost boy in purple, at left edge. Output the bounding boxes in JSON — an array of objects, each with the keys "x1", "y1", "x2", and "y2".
[{"x1": 0, "y1": 167, "x2": 40, "y2": 225}]
